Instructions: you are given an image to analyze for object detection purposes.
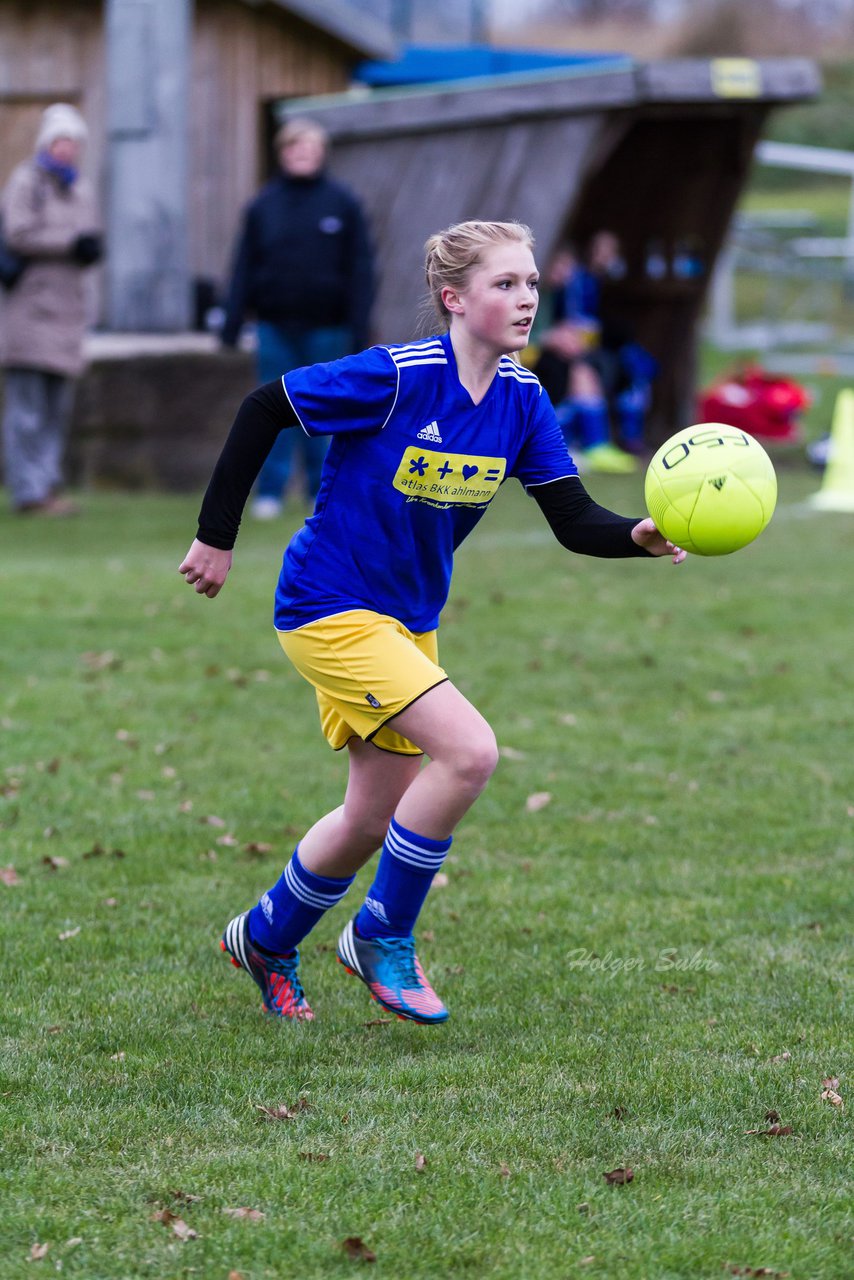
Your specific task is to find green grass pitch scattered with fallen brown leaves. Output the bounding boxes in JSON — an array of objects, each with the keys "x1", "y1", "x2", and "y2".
[{"x1": 0, "y1": 473, "x2": 854, "y2": 1280}]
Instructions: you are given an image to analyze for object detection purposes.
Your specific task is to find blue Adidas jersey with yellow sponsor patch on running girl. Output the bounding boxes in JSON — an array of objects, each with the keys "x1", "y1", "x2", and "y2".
[{"x1": 275, "y1": 334, "x2": 577, "y2": 632}]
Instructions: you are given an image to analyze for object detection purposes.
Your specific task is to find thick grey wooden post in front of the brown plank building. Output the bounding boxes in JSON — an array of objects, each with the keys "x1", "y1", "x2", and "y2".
[{"x1": 106, "y1": 0, "x2": 192, "y2": 333}]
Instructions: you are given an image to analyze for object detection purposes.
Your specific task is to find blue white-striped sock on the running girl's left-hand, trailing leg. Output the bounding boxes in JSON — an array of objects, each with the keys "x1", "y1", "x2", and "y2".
[{"x1": 247, "y1": 845, "x2": 356, "y2": 955}]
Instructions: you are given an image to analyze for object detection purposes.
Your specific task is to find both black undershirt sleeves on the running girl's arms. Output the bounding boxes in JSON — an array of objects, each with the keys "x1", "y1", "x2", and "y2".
[{"x1": 197, "y1": 381, "x2": 648, "y2": 559}]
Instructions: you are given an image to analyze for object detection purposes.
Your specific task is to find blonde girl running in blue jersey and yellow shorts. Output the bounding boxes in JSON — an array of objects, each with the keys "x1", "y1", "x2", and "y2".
[{"x1": 179, "y1": 221, "x2": 685, "y2": 1023}]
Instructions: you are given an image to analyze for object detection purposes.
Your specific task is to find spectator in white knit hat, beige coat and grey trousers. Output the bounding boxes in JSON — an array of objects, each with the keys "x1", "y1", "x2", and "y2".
[{"x1": 0, "y1": 102, "x2": 101, "y2": 516}]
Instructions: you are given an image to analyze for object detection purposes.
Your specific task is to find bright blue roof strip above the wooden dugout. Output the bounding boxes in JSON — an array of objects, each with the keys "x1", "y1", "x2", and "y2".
[{"x1": 353, "y1": 45, "x2": 626, "y2": 88}]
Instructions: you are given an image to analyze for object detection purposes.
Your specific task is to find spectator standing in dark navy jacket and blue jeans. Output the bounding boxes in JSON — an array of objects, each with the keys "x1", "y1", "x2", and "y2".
[{"x1": 223, "y1": 119, "x2": 374, "y2": 520}]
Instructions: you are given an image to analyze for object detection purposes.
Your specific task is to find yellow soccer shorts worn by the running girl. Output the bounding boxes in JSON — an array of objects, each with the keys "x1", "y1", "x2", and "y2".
[{"x1": 277, "y1": 609, "x2": 448, "y2": 755}]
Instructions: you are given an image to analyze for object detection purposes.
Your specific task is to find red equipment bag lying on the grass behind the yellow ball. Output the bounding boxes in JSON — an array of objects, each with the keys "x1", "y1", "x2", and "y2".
[{"x1": 698, "y1": 366, "x2": 809, "y2": 444}]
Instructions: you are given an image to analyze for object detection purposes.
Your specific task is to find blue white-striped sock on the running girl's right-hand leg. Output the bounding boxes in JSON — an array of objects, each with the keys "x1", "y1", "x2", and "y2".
[{"x1": 356, "y1": 818, "x2": 451, "y2": 938}]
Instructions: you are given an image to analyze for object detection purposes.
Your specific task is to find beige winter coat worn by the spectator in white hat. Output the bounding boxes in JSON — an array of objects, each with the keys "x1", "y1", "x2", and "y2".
[{"x1": 0, "y1": 160, "x2": 99, "y2": 376}]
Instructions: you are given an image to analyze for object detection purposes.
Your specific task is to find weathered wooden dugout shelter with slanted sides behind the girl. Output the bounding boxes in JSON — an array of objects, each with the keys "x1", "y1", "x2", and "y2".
[{"x1": 286, "y1": 59, "x2": 819, "y2": 438}]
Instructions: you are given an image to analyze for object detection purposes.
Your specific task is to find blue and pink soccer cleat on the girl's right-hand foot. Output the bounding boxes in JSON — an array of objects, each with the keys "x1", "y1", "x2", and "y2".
[{"x1": 338, "y1": 920, "x2": 448, "y2": 1023}]
